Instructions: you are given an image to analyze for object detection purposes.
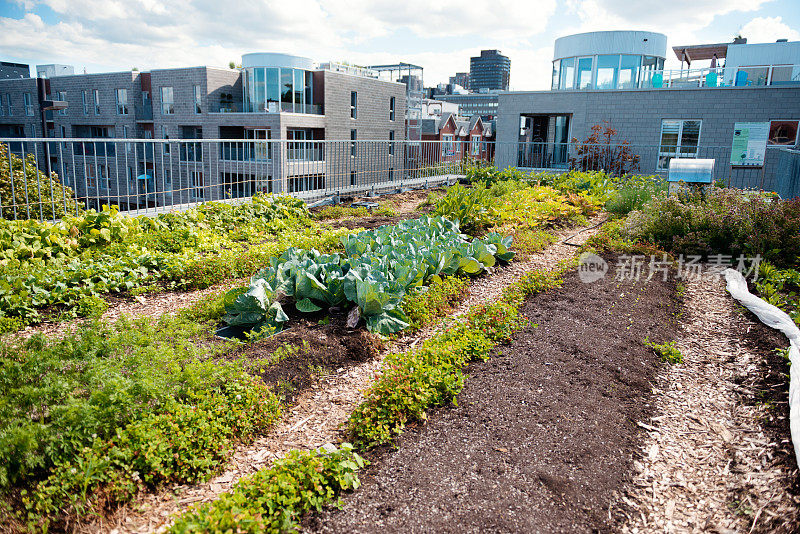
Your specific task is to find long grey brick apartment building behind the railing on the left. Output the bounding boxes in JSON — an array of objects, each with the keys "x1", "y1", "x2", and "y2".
[{"x1": 0, "y1": 53, "x2": 406, "y2": 207}]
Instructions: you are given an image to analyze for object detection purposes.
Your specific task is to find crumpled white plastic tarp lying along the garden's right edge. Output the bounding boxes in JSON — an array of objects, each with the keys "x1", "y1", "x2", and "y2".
[{"x1": 724, "y1": 269, "x2": 800, "y2": 465}]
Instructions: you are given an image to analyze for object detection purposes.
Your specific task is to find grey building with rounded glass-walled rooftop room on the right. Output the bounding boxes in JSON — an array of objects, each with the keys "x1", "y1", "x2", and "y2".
[{"x1": 497, "y1": 31, "x2": 800, "y2": 192}]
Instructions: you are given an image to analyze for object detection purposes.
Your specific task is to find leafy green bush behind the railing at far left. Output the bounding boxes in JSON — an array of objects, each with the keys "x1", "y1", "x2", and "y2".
[{"x1": 0, "y1": 144, "x2": 82, "y2": 220}]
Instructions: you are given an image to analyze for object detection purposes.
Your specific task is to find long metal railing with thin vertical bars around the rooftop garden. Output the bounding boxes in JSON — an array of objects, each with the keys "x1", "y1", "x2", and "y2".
[{"x1": 0, "y1": 138, "x2": 792, "y2": 220}]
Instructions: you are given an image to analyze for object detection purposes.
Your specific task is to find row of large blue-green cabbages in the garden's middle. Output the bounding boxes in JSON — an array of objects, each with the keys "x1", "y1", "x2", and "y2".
[{"x1": 225, "y1": 216, "x2": 514, "y2": 335}]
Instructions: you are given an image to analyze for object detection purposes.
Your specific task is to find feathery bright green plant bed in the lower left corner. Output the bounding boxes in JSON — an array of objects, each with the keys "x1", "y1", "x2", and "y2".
[{"x1": 0, "y1": 315, "x2": 279, "y2": 530}]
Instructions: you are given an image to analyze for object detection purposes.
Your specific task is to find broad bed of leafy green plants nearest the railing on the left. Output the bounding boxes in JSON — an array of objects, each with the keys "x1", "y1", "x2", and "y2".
[{"x1": 0, "y1": 195, "x2": 349, "y2": 330}]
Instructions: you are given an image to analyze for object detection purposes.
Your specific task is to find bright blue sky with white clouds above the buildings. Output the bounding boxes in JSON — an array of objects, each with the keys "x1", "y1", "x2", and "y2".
[{"x1": 0, "y1": 0, "x2": 800, "y2": 90}]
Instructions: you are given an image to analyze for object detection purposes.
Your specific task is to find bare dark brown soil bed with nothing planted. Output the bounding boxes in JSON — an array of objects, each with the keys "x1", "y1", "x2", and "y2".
[{"x1": 305, "y1": 258, "x2": 677, "y2": 532}]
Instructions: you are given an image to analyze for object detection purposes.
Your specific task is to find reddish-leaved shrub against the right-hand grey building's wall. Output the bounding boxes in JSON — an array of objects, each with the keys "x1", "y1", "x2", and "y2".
[{"x1": 569, "y1": 121, "x2": 639, "y2": 176}]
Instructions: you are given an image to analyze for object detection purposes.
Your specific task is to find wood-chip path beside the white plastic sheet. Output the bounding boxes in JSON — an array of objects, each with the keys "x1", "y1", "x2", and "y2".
[{"x1": 623, "y1": 277, "x2": 800, "y2": 533}]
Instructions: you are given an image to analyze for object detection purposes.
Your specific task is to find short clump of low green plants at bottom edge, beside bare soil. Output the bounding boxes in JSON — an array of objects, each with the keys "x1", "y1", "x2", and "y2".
[{"x1": 170, "y1": 443, "x2": 367, "y2": 534}]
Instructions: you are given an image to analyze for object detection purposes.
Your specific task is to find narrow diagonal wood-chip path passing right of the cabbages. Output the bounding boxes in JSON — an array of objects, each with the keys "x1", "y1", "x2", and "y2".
[{"x1": 94, "y1": 218, "x2": 601, "y2": 534}]
